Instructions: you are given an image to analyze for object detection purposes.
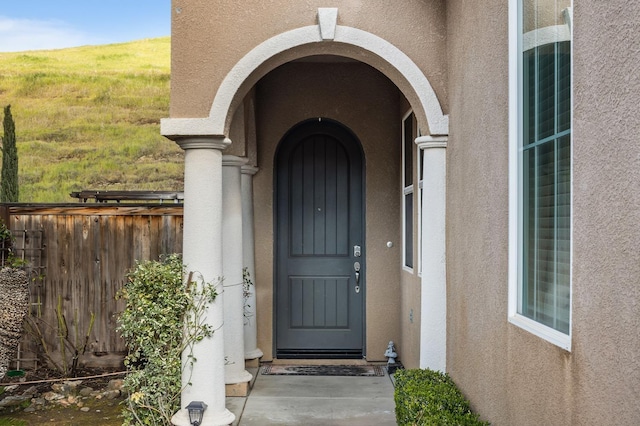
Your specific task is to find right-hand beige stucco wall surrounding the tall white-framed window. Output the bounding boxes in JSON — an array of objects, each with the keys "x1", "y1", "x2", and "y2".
[{"x1": 447, "y1": 0, "x2": 640, "y2": 425}]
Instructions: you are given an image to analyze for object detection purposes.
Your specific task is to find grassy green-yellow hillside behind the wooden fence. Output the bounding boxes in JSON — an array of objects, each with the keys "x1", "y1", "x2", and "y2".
[{"x1": 0, "y1": 37, "x2": 183, "y2": 202}]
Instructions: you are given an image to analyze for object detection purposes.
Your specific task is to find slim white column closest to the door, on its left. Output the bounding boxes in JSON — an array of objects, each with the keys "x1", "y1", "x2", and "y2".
[{"x1": 241, "y1": 164, "x2": 262, "y2": 359}]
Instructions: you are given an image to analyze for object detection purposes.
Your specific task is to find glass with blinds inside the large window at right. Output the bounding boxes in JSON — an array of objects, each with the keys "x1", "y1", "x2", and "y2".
[{"x1": 518, "y1": 0, "x2": 571, "y2": 334}]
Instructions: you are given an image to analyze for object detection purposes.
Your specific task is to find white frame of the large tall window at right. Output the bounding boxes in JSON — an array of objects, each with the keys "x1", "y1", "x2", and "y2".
[{"x1": 508, "y1": 0, "x2": 573, "y2": 351}]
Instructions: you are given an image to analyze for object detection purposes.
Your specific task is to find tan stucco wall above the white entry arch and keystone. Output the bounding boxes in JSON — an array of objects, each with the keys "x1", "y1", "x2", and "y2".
[{"x1": 170, "y1": 0, "x2": 447, "y2": 133}]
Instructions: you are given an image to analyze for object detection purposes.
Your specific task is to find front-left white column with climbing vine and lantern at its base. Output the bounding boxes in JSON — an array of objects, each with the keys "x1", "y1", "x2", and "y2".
[{"x1": 171, "y1": 137, "x2": 235, "y2": 426}]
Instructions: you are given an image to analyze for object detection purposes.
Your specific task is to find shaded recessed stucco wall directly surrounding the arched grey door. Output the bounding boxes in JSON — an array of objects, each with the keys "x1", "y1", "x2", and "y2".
[{"x1": 254, "y1": 63, "x2": 401, "y2": 361}]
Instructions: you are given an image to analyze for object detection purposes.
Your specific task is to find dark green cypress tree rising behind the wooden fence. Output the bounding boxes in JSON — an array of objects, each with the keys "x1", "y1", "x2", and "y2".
[{"x1": 0, "y1": 105, "x2": 18, "y2": 203}]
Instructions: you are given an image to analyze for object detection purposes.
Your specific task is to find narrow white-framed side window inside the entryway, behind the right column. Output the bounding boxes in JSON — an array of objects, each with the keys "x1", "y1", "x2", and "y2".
[{"x1": 402, "y1": 112, "x2": 416, "y2": 271}]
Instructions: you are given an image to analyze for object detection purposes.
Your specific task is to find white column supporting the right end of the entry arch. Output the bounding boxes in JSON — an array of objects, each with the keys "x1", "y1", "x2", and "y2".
[{"x1": 416, "y1": 136, "x2": 448, "y2": 372}]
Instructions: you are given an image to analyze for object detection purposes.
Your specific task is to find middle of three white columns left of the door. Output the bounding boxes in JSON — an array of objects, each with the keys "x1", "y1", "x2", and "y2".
[{"x1": 222, "y1": 155, "x2": 252, "y2": 385}]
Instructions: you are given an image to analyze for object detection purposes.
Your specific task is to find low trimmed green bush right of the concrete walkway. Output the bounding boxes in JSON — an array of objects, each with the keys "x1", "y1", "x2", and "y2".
[{"x1": 394, "y1": 369, "x2": 489, "y2": 426}]
